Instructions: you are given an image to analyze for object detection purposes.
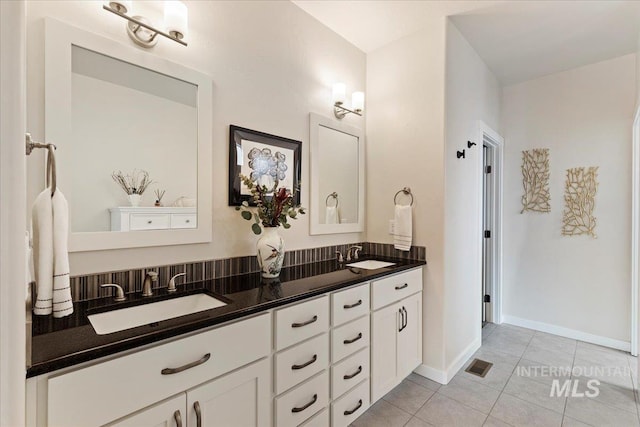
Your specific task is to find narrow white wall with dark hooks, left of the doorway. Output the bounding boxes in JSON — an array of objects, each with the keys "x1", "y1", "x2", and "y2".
[{"x1": 444, "y1": 21, "x2": 502, "y2": 373}]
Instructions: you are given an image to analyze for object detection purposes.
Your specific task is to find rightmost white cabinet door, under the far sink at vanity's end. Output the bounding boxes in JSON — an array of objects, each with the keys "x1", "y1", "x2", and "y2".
[{"x1": 398, "y1": 292, "x2": 422, "y2": 381}]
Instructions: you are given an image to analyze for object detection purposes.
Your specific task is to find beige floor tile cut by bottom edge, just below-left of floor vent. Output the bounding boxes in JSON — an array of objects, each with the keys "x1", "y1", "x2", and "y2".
[{"x1": 416, "y1": 393, "x2": 487, "y2": 427}]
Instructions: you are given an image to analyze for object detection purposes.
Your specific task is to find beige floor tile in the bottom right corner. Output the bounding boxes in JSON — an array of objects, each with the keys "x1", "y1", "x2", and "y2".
[{"x1": 565, "y1": 397, "x2": 640, "y2": 427}]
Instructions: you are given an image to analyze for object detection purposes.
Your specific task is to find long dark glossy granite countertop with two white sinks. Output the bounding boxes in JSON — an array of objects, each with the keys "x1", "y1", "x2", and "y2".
[{"x1": 27, "y1": 257, "x2": 426, "y2": 377}]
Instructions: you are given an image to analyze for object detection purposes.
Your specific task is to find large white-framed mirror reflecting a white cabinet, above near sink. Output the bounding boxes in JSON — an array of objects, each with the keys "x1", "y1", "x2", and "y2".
[{"x1": 45, "y1": 18, "x2": 212, "y2": 252}]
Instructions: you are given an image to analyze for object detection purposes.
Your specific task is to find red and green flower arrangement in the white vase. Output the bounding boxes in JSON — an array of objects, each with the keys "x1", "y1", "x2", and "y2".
[{"x1": 236, "y1": 174, "x2": 305, "y2": 234}]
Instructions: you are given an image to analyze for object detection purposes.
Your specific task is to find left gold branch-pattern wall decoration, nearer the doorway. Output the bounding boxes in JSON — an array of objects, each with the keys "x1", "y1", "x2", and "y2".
[{"x1": 520, "y1": 148, "x2": 551, "y2": 213}]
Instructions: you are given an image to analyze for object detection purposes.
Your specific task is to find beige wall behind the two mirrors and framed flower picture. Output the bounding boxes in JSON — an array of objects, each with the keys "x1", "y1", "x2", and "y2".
[{"x1": 27, "y1": 1, "x2": 366, "y2": 275}]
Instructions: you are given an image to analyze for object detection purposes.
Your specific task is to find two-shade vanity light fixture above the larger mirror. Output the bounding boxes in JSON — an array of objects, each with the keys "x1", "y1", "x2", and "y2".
[{"x1": 102, "y1": 0, "x2": 188, "y2": 47}]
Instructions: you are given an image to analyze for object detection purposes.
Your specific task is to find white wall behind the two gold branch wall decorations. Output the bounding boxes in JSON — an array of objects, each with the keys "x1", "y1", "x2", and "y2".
[{"x1": 502, "y1": 54, "x2": 636, "y2": 342}]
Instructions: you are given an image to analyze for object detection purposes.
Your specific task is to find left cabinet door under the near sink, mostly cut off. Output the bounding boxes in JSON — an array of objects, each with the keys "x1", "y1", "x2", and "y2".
[{"x1": 108, "y1": 393, "x2": 187, "y2": 427}]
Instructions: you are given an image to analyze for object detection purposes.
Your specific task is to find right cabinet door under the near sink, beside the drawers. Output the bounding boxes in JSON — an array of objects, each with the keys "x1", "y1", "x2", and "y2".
[{"x1": 187, "y1": 359, "x2": 271, "y2": 427}]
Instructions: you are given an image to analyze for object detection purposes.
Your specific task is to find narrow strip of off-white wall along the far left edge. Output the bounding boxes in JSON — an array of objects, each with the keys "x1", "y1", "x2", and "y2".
[{"x1": 0, "y1": 1, "x2": 26, "y2": 426}]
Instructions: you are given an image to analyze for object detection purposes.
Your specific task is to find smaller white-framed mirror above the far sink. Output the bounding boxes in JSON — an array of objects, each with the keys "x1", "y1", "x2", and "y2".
[{"x1": 309, "y1": 113, "x2": 364, "y2": 234}]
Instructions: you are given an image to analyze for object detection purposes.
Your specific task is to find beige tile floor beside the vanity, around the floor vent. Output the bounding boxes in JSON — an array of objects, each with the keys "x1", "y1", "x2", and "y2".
[{"x1": 352, "y1": 324, "x2": 640, "y2": 427}]
